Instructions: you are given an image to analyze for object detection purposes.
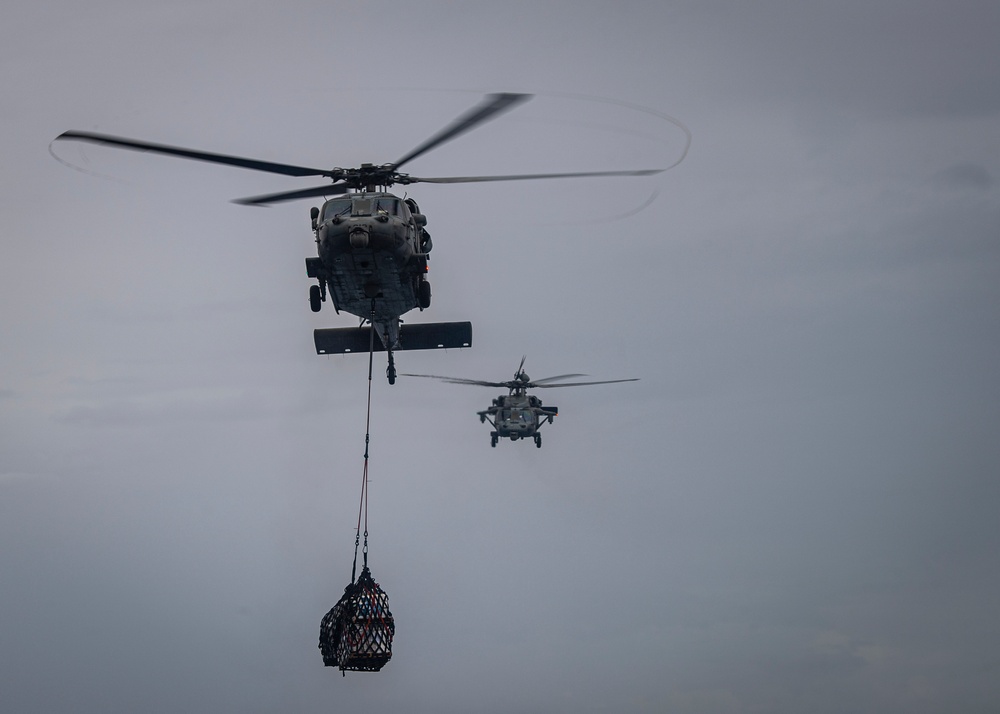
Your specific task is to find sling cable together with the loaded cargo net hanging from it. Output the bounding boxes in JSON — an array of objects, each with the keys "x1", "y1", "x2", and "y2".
[{"x1": 319, "y1": 300, "x2": 396, "y2": 674}]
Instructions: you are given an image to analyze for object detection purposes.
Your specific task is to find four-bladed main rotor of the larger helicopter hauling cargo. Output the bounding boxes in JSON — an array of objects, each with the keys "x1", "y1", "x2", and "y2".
[{"x1": 55, "y1": 93, "x2": 664, "y2": 206}]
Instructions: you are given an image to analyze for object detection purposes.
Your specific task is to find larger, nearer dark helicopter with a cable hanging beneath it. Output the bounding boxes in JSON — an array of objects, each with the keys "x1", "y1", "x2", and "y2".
[{"x1": 55, "y1": 93, "x2": 664, "y2": 384}]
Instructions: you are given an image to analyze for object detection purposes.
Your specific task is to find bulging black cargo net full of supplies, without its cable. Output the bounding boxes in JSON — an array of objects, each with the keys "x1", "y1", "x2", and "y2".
[{"x1": 319, "y1": 565, "x2": 396, "y2": 672}]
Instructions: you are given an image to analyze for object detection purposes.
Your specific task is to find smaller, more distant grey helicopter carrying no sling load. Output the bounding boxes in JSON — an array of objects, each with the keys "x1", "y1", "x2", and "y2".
[{"x1": 402, "y1": 356, "x2": 639, "y2": 449}]
